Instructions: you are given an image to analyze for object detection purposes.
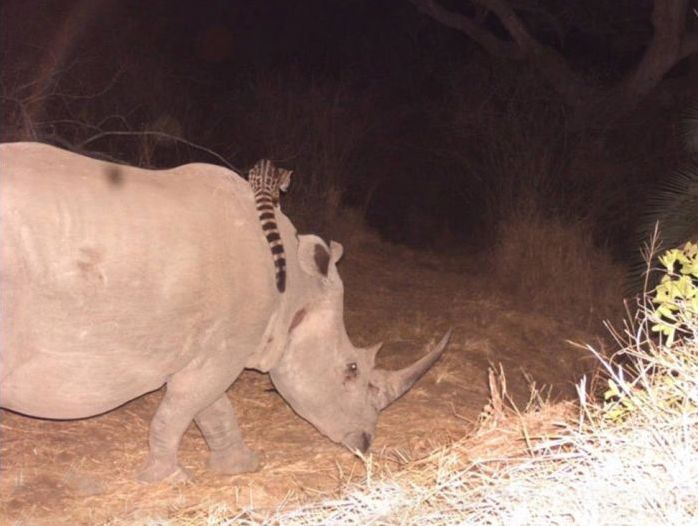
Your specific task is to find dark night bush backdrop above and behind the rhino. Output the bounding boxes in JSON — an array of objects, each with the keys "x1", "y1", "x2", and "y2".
[{"x1": 1, "y1": 0, "x2": 698, "y2": 257}]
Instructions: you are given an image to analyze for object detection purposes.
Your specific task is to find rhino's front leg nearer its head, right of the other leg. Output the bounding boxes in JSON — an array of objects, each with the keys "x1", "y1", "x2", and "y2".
[{"x1": 196, "y1": 393, "x2": 259, "y2": 475}]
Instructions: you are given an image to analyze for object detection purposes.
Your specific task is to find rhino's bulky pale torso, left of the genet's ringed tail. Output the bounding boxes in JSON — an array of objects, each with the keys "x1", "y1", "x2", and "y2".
[{"x1": 0, "y1": 143, "x2": 273, "y2": 418}]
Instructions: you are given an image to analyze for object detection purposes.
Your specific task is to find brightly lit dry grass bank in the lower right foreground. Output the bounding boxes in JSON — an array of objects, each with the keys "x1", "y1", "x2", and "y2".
[{"x1": 136, "y1": 280, "x2": 698, "y2": 526}]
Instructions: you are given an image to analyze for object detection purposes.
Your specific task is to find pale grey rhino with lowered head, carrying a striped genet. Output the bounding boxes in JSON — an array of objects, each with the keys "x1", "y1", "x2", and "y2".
[{"x1": 0, "y1": 143, "x2": 447, "y2": 481}]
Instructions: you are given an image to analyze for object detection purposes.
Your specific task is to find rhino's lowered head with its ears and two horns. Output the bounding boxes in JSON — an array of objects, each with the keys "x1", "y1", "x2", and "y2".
[{"x1": 270, "y1": 236, "x2": 449, "y2": 452}]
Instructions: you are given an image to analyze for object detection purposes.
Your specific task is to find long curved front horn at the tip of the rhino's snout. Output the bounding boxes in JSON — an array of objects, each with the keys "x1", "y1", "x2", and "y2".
[{"x1": 371, "y1": 329, "x2": 451, "y2": 410}]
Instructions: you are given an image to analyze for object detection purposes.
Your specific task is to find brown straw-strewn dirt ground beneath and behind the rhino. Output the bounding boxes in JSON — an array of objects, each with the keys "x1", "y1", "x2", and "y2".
[{"x1": 0, "y1": 241, "x2": 598, "y2": 525}]
